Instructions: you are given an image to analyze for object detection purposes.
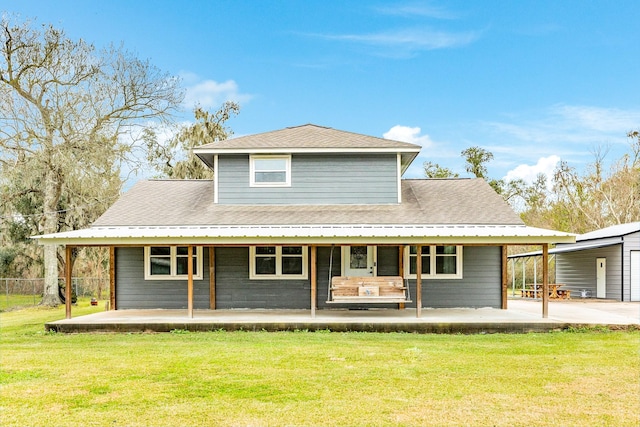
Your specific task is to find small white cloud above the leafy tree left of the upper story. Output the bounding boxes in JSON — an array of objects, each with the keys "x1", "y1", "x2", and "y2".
[{"x1": 183, "y1": 77, "x2": 252, "y2": 109}]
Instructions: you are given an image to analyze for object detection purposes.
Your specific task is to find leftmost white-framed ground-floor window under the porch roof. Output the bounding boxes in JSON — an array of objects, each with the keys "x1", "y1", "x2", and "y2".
[{"x1": 144, "y1": 246, "x2": 202, "y2": 280}]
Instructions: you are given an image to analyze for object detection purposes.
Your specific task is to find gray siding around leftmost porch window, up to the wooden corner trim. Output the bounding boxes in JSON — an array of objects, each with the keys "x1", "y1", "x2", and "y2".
[{"x1": 116, "y1": 248, "x2": 209, "y2": 310}]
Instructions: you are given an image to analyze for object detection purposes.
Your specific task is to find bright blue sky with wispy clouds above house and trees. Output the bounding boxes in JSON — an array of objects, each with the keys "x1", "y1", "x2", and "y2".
[{"x1": 5, "y1": 0, "x2": 640, "y2": 178}]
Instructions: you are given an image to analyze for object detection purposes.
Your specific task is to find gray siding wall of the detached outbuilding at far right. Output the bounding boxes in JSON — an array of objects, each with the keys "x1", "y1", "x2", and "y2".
[{"x1": 556, "y1": 245, "x2": 628, "y2": 301}]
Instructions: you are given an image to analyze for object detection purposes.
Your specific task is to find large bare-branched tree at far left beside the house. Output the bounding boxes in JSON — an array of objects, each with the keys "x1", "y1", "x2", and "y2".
[{"x1": 0, "y1": 16, "x2": 183, "y2": 305}]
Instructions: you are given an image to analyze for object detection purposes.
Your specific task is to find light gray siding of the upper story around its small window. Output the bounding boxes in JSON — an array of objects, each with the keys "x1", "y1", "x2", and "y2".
[{"x1": 218, "y1": 154, "x2": 398, "y2": 205}]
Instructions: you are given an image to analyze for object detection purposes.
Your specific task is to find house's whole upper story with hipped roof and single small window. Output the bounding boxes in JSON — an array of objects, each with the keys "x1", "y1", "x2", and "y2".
[{"x1": 194, "y1": 124, "x2": 420, "y2": 205}]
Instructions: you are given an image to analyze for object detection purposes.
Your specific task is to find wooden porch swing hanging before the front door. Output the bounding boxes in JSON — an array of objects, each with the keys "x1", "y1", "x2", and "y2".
[{"x1": 327, "y1": 246, "x2": 411, "y2": 304}]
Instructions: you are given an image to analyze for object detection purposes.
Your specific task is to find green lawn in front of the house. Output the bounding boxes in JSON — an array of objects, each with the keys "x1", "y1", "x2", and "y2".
[{"x1": 0, "y1": 301, "x2": 640, "y2": 426}]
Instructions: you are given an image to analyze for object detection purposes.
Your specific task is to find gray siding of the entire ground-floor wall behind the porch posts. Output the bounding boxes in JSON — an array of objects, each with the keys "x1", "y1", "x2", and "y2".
[{"x1": 116, "y1": 246, "x2": 501, "y2": 309}]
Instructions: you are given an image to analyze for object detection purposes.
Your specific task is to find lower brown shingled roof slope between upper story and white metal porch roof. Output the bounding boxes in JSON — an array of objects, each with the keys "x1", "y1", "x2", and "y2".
[{"x1": 93, "y1": 179, "x2": 523, "y2": 227}]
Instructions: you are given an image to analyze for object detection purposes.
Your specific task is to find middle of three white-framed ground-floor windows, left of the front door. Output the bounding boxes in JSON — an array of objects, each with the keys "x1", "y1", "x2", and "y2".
[{"x1": 249, "y1": 246, "x2": 308, "y2": 279}]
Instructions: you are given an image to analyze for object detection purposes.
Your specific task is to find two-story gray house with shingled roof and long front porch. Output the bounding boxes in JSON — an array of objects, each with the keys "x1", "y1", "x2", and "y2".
[{"x1": 38, "y1": 124, "x2": 574, "y2": 316}]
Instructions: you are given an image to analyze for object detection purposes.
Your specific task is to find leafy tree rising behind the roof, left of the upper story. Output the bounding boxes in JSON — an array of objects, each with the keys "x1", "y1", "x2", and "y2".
[{"x1": 144, "y1": 101, "x2": 240, "y2": 179}]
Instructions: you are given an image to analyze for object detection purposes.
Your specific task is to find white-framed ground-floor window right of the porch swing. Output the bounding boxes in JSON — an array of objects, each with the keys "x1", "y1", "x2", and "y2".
[{"x1": 405, "y1": 245, "x2": 462, "y2": 279}]
